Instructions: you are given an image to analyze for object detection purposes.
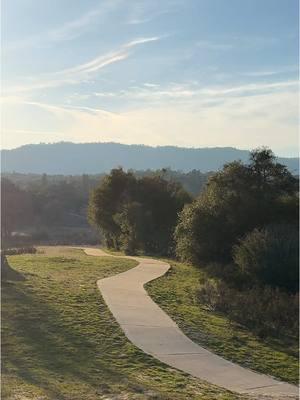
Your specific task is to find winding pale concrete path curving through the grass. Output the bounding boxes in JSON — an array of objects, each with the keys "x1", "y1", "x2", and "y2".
[{"x1": 84, "y1": 248, "x2": 298, "y2": 399}]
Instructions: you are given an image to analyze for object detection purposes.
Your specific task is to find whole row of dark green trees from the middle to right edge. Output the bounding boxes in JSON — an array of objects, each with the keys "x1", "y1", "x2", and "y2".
[{"x1": 89, "y1": 148, "x2": 298, "y2": 291}]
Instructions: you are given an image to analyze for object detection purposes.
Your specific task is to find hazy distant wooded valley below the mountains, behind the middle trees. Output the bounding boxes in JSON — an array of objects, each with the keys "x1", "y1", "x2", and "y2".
[{"x1": 1, "y1": 168, "x2": 210, "y2": 245}]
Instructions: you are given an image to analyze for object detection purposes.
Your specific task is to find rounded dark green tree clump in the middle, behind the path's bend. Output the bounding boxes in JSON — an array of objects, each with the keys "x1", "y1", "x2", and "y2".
[{"x1": 89, "y1": 168, "x2": 191, "y2": 254}]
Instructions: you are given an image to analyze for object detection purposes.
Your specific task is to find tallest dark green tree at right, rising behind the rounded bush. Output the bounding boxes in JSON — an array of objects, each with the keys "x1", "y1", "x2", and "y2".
[{"x1": 175, "y1": 148, "x2": 298, "y2": 263}]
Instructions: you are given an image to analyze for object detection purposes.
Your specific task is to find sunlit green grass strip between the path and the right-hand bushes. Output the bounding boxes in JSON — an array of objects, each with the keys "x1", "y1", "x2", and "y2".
[{"x1": 147, "y1": 261, "x2": 298, "y2": 383}]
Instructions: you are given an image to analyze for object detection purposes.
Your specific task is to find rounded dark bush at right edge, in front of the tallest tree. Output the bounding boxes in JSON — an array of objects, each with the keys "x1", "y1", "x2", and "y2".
[{"x1": 233, "y1": 225, "x2": 299, "y2": 292}]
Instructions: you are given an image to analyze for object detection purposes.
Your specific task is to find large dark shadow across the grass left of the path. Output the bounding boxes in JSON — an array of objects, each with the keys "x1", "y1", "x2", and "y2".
[{"x1": 2, "y1": 276, "x2": 135, "y2": 399}]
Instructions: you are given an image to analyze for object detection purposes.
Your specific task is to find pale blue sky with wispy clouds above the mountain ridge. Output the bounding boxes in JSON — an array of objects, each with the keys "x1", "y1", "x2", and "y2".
[{"x1": 1, "y1": 0, "x2": 299, "y2": 156}]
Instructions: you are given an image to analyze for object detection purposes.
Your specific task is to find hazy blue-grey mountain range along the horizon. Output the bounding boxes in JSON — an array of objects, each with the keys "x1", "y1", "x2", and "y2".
[{"x1": 1, "y1": 142, "x2": 299, "y2": 175}]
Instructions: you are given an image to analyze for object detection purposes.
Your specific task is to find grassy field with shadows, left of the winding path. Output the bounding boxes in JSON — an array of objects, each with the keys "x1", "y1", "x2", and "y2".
[{"x1": 2, "y1": 248, "x2": 246, "y2": 400}]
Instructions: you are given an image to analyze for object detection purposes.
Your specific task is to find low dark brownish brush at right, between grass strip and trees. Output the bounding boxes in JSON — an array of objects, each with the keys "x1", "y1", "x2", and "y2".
[{"x1": 197, "y1": 280, "x2": 299, "y2": 337}]
